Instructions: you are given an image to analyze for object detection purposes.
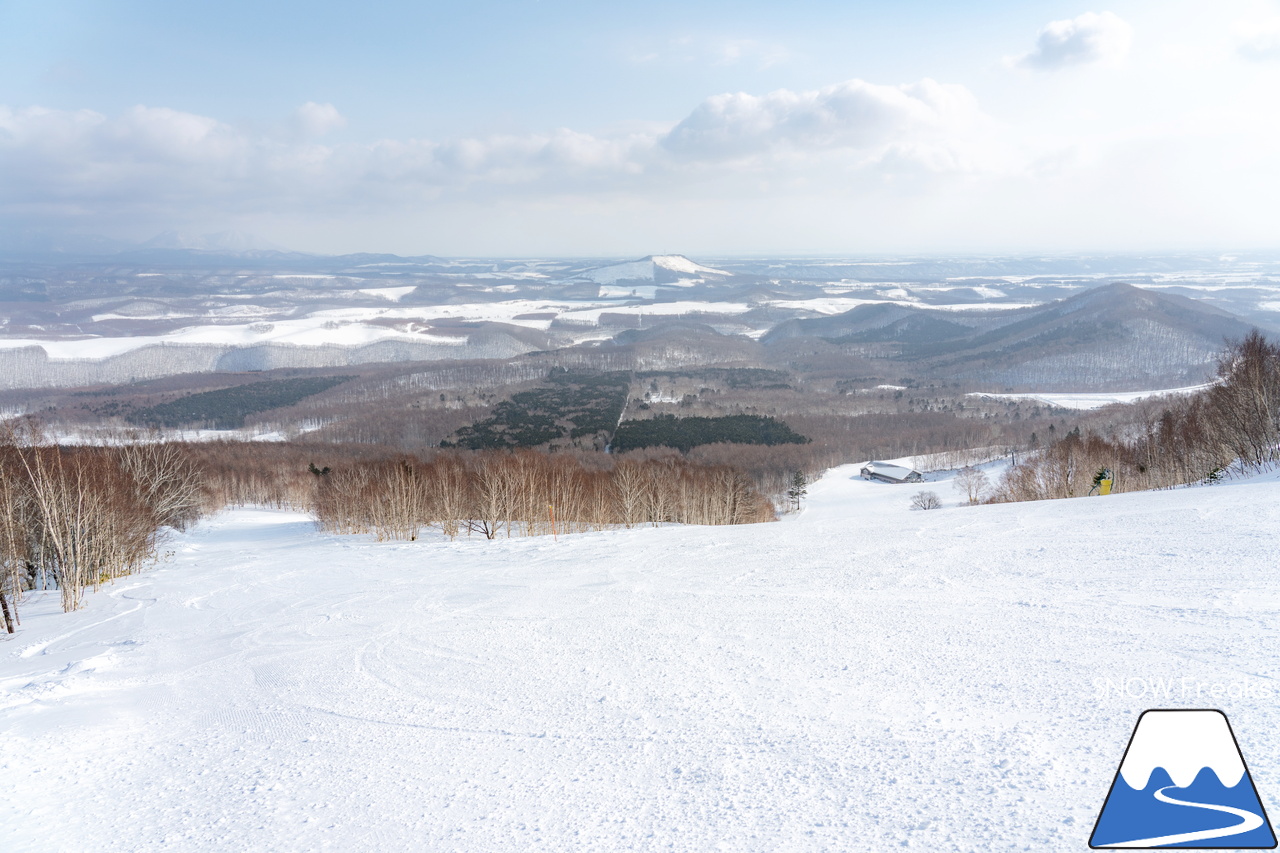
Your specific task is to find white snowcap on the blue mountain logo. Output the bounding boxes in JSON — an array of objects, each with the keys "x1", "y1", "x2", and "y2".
[{"x1": 1120, "y1": 711, "x2": 1244, "y2": 790}]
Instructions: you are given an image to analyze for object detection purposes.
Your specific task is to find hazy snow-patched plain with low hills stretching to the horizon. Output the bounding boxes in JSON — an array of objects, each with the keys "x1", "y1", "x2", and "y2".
[{"x1": 0, "y1": 245, "x2": 1280, "y2": 391}]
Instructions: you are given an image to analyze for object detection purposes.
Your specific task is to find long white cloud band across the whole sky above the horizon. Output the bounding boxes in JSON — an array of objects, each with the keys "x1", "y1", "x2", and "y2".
[{"x1": 12, "y1": 61, "x2": 1280, "y2": 254}]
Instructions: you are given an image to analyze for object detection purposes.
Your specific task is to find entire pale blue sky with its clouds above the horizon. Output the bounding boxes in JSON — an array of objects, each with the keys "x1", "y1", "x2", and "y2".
[{"x1": 0, "y1": 0, "x2": 1280, "y2": 255}]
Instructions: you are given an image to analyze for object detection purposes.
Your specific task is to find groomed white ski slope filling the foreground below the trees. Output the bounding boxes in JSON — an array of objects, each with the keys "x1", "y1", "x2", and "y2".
[{"x1": 0, "y1": 466, "x2": 1280, "y2": 852}]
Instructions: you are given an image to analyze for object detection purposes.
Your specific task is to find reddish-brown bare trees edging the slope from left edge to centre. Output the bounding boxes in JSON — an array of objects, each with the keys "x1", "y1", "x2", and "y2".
[{"x1": 0, "y1": 430, "x2": 774, "y2": 633}]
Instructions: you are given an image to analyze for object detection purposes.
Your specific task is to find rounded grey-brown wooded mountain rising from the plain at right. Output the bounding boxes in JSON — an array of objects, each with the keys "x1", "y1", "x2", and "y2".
[{"x1": 763, "y1": 284, "x2": 1253, "y2": 389}]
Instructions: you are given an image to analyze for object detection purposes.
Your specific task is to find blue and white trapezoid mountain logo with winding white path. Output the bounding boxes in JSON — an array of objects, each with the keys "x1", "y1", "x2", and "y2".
[{"x1": 1089, "y1": 710, "x2": 1276, "y2": 850}]
